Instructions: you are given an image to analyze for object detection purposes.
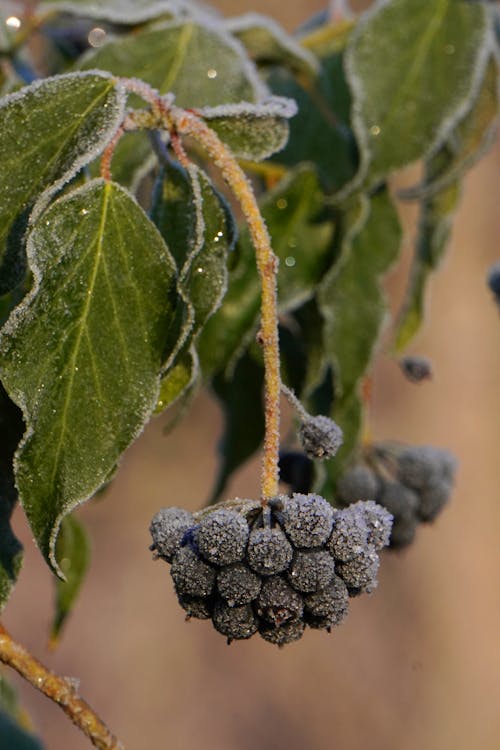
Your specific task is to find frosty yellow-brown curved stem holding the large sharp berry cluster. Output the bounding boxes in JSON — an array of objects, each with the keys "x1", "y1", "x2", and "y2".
[{"x1": 170, "y1": 107, "x2": 281, "y2": 505}]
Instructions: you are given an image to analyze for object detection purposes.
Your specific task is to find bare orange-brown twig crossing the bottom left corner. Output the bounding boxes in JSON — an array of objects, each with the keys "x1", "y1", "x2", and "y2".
[{"x1": 0, "y1": 625, "x2": 123, "y2": 750}]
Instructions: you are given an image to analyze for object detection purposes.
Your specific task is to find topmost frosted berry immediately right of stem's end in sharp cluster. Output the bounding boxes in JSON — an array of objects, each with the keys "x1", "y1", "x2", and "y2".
[{"x1": 281, "y1": 494, "x2": 333, "y2": 548}]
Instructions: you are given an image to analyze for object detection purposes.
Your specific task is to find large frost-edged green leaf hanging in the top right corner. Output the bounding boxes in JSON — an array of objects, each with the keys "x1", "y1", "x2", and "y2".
[{"x1": 346, "y1": 0, "x2": 492, "y2": 183}]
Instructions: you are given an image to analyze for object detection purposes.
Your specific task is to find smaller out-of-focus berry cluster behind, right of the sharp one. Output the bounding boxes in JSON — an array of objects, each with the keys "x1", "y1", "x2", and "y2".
[{"x1": 337, "y1": 445, "x2": 456, "y2": 547}]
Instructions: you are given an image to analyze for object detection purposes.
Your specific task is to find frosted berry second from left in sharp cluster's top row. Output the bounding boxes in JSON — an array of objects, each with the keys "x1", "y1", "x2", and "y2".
[{"x1": 196, "y1": 508, "x2": 249, "y2": 565}]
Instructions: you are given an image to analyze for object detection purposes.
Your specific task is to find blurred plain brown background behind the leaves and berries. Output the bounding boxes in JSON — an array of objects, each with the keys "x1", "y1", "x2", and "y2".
[{"x1": 5, "y1": 0, "x2": 500, "y2": 750}]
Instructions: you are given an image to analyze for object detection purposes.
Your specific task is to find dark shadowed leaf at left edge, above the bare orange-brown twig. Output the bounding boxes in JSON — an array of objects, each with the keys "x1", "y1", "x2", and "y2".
[{"x1": 0, "y1": 384, "x2": 24, "y2": 610}]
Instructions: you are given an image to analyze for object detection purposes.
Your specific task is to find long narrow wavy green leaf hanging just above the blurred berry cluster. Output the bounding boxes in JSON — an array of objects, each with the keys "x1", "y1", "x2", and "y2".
[{"x1": 318, "y1": 188, "x2": 401, "y2": 475}]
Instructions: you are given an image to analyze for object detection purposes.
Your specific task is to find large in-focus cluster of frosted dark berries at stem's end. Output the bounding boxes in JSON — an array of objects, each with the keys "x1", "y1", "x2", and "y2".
[{"x1": 150, "y1": 494, "x2": 392, "y2": 646}]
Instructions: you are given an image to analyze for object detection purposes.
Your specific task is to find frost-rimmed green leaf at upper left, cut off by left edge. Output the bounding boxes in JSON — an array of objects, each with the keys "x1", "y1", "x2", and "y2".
[{"x1": 0, "y1": 71, "x2": 124, "y2": 293}]
